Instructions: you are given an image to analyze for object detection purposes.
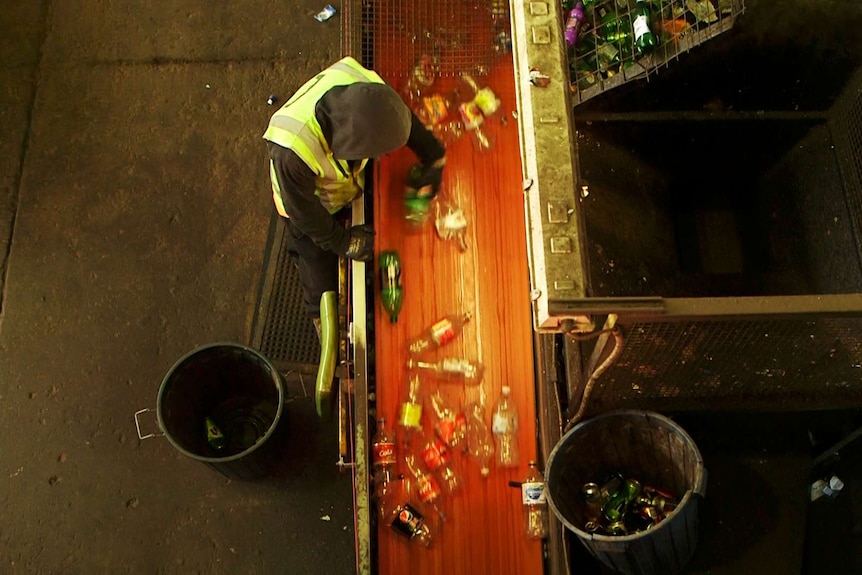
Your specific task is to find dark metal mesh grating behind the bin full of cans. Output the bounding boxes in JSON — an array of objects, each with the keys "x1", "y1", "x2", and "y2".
[{"x1": 589, "y1": 317, "x2": 862, "y2": 413}]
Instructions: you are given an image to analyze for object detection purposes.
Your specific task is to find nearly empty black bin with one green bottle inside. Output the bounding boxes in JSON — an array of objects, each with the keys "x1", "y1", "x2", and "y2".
[{"x1": 156, "y1": 343, "x2": 284, "y2": 479}]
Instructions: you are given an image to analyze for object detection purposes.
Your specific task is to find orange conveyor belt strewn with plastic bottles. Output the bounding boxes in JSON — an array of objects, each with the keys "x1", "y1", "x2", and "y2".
[{"x1": 373, "y1": 57, "x2": 543, "y2": 575}]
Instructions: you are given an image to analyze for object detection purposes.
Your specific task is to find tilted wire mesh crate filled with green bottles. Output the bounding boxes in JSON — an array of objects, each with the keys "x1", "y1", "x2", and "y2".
[{"x1": 563, "y1": 0, "x2": 745, "y2": 105}]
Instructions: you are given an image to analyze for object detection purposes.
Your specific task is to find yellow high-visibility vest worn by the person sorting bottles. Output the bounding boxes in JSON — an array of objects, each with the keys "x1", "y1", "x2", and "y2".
[{"x1": 263, "y1": 56, "x2": 384, "y2": 216}]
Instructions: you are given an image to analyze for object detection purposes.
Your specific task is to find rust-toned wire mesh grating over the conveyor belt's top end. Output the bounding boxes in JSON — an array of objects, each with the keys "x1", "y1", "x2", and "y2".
[{"x1": 352, "y1": 0, "x2": 512, "y2": 80}]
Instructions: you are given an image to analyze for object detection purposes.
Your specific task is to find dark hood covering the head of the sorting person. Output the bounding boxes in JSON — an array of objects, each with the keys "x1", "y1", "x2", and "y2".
[{"x1": 326, "y1": 82, "x2": 411, "y2": 160}]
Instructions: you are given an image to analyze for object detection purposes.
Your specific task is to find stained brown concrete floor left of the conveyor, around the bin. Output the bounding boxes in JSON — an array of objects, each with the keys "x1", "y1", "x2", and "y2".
[{"x1": 5, "y1": 0, "x2": 862, "y2": 575}]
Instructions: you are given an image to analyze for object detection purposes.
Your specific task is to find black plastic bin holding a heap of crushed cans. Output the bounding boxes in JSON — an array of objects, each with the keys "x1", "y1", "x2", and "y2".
[{"x1": 545, "y1": 410, "x2": 706, "y2": 575}]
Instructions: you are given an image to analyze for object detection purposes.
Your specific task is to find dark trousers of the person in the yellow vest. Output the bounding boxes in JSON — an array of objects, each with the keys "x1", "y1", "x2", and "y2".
[{"x1": 287, "y1": 218, "x2": 338, "y2": 318}]
